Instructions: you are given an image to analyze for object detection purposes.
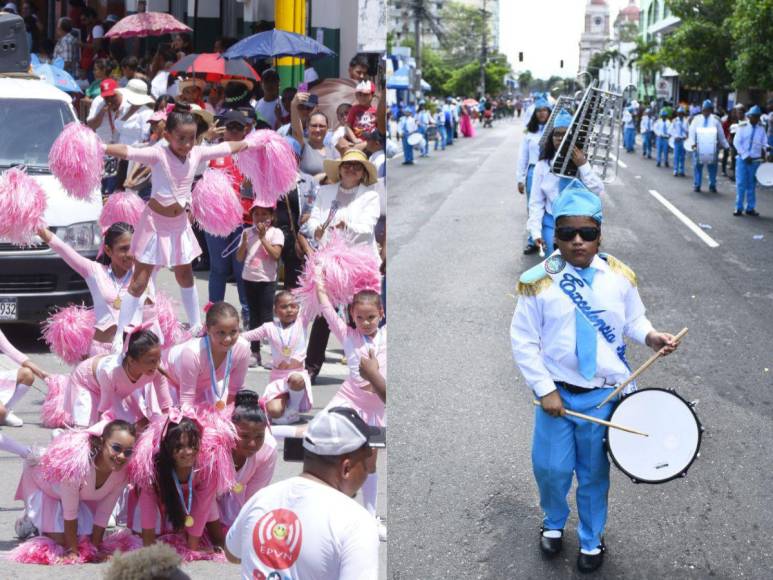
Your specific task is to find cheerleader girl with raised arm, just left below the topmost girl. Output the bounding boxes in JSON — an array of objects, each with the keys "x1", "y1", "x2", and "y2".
[{"x1": 37, "y1": 222, "x2": 155, "y2": 356}]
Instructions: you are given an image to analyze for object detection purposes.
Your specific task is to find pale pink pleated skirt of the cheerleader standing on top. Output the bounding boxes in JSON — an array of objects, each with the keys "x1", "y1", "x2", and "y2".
[{"x1": 131, "y1": 206, "x2": 201, "y2": 267}]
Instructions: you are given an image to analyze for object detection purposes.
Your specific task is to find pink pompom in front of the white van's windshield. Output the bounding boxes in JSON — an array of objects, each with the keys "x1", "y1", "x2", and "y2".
[{"x1": 48, "y1": 121, "x2": 105, "y2": 200}]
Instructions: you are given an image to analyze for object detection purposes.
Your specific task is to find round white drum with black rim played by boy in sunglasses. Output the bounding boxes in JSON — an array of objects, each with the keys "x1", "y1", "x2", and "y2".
[{"x1": 607, "y1": 389, "x2": 701, "y2": 483}]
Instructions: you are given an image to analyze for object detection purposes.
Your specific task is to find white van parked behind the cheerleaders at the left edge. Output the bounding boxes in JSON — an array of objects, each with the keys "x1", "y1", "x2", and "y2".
[{"x1": 0, "y1": 73, "x2": 102, "y2": 324}]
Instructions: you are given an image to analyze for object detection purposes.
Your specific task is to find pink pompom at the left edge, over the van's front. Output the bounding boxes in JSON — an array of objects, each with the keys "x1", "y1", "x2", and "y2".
[{"x1": 0, "y1": 167, "x2": 47, "y2": 246}]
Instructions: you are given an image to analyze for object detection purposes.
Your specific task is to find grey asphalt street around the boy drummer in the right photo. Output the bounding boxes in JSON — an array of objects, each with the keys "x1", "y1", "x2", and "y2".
[{"x1": 388, "y1": 115, "x2": 773, "y2": 580}]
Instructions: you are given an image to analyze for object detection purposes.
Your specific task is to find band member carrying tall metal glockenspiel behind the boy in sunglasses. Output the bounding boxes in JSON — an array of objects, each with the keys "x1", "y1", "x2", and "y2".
[{"x1": 526, "y1": 111, "x2": 604, "y2": 254}]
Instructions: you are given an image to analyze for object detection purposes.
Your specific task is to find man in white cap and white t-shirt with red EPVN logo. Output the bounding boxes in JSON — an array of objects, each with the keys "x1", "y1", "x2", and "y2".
[{"x1": 226, "y1": 407, "x2": 383, "y2": 580}]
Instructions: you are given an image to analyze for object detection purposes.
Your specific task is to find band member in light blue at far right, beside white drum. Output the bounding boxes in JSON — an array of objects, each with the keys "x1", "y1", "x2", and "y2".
[{"x1": 733, "y1": 105, "x2": 766, "y2": 216}]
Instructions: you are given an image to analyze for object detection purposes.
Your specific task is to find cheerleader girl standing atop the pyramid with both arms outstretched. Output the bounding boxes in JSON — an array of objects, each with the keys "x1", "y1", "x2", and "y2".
[{"x1": 105, "y1": 105, "x2": 247, "y2": 352}]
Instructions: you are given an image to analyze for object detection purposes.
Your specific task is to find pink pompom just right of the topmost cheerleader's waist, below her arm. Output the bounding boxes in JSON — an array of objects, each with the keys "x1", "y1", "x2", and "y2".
[{"x1": 191, "y1": 169, "x2": 244, "y2": 238}]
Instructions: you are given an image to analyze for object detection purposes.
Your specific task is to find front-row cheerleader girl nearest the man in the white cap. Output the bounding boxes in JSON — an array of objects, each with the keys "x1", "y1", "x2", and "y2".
[{"x1": 209, "y1": 389, "x2": 276, "y2": 527}]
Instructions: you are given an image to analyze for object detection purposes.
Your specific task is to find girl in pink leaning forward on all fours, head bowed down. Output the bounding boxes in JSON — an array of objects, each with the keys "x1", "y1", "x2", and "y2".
[{"x1": 42, "y1": 323, "x2": 173, "y2": 427}]
